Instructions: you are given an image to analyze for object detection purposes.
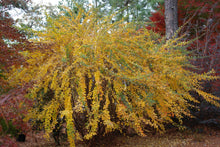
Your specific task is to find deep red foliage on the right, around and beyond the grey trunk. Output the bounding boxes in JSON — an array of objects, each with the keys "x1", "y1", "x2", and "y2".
[{"x1": 147, "y1": 0, "x2": 220, "y2": 124}]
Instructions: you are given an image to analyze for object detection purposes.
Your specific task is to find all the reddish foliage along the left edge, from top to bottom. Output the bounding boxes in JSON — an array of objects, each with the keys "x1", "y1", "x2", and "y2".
[{"x1": 0, "y1": 0, "x2": 31, "y2": 145}]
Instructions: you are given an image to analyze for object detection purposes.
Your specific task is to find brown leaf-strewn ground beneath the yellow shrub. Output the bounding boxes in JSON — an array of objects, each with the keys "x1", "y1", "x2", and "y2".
[{"x1": 9, "y1": 128, "x2": 220, "y2": 147}]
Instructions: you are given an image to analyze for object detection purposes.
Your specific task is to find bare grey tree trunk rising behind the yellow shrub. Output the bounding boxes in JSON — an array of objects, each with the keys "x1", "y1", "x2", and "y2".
[{"x1": 165, "y1": 0, "x2": 178, "y2": 40}]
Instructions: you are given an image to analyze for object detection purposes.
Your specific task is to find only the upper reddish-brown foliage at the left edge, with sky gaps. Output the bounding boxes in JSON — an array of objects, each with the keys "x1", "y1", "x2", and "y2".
[{"x1": 0, "y1": 0, "x2": 31, "y2": 93}]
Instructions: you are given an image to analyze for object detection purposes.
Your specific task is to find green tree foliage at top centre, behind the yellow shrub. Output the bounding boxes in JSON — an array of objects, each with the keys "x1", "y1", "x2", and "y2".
[{"x1": 72, "y1": 0, "x2": 163, "y2": 22}]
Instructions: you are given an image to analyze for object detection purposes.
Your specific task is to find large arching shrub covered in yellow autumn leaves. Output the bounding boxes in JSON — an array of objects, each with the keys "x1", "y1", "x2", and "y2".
[{"x1": 7, "y1": 6, "x2": 219, "y2": 146}]
